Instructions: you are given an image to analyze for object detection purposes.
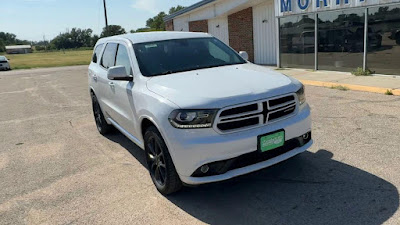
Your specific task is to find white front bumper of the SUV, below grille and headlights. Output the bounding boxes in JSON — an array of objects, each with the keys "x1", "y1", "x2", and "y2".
[{"x1": 163, "y1": 104, "x2": 313, "y2": 185}]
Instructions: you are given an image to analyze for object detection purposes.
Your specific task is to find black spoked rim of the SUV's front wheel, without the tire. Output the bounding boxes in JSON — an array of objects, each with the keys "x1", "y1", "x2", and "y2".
[{"x1": 147, "y1": 137, "x2": 167, "y2": 186}]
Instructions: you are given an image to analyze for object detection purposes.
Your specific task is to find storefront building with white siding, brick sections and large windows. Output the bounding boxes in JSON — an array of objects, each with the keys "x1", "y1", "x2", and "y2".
[{"x1": 164, "y1": 0, "x2": 400, "y2": 75}]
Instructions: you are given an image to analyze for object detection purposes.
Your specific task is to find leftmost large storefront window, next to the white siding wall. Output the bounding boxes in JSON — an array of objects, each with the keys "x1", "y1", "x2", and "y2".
[{"x1": 279, "y1": 15, "x2": 315, "y2": 69}]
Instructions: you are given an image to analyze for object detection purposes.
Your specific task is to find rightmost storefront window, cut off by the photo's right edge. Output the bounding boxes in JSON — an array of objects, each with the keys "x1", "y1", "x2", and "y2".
[{"x1": 367, "y1": 5, "x2": 400, "y2": 74}]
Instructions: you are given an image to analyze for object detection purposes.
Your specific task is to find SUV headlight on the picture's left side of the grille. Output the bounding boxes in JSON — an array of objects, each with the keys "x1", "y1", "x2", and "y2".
[{"x1": 168, "y1": 109, "x2": 217, "y2": 129}]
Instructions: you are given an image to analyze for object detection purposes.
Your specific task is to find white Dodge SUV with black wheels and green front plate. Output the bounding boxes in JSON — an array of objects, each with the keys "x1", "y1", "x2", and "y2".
[{"x1": 89, "y1": 32, "x2": 312, "y2": 194}]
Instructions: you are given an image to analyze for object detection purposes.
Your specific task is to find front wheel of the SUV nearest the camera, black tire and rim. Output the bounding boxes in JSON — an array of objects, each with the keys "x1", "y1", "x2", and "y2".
[{"x1": 144, "y1": 126, "x2": 182, "y2": 195}]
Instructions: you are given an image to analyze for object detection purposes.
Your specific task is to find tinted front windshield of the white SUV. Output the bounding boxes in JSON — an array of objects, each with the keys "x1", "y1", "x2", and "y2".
[{"x1": 134, "y1": 38, "x2": 246, "y2": 76}]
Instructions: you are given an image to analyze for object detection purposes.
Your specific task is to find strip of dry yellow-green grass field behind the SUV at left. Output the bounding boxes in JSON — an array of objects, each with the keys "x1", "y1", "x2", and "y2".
[{"x1": 6, "y1": 50, "x2": 92, "y2": 69}]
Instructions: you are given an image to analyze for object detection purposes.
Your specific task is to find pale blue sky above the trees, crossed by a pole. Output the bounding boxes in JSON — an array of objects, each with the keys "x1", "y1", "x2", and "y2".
[{"x1": 0, "y1": 0, "x2": 200, "y2": 41}]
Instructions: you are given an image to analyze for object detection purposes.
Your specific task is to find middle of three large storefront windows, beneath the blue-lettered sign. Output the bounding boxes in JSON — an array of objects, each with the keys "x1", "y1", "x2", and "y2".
[{"x1": 318, "y1": 9, "x2": 365, "y2": 71}]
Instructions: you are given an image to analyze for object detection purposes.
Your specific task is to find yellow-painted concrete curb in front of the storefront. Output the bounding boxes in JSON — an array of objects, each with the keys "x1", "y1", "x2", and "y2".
[{"x1": 300, "y1": 80, "x2": 400, "y2": 96}]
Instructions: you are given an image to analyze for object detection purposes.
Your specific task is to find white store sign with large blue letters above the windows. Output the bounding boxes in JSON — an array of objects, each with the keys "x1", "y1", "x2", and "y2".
[{"x1": 275, "y1": 0, "x2": 400, "y2": 16}]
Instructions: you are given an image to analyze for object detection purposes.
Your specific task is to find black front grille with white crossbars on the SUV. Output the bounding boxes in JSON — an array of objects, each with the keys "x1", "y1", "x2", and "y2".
[{"x1": 215, "y1": 94, "x2": 297, "y2": 133}]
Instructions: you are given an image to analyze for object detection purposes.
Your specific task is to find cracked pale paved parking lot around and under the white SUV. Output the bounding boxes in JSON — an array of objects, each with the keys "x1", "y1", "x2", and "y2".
[{"x1": 0, "y1": 66, "x2": 400, "y2": 224}]
